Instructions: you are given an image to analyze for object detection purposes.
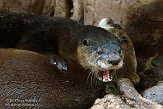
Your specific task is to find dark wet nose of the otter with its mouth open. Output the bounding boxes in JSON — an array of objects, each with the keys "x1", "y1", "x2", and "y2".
[{"x1": 108, "y1": 54, "x2": 121, "y2": 65}]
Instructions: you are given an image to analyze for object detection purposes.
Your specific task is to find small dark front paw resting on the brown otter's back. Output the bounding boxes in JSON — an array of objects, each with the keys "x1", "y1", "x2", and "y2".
[{"x1": 50, "y1": 57, "x2": 67, "y2": 71}]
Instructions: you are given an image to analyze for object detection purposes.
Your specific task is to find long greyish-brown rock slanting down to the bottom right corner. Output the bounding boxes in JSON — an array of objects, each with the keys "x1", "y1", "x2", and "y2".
[{"x1": 117, "y1": 78, "x2": 163, "y2": 109}]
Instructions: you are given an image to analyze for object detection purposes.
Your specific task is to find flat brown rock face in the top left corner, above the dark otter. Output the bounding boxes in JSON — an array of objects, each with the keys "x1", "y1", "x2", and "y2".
[{"x1": 0, "y1": 0, "x2": 55, "y2": 15}]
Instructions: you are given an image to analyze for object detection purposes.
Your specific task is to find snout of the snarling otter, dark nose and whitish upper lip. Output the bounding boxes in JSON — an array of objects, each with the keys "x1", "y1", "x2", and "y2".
[{"x1": 97, "y1": 53, "x2": 122, "y2": 68}]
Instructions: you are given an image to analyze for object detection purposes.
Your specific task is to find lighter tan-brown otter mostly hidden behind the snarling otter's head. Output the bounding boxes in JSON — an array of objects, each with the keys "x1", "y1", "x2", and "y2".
[{"x1": 98, "y1": 18, "x2": 140, "y2": 85}]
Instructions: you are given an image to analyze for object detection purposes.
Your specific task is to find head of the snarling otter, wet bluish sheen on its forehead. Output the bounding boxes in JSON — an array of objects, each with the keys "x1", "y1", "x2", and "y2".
[{"x1": 77, "y1": 26, "x2": 124, "y2": 82}]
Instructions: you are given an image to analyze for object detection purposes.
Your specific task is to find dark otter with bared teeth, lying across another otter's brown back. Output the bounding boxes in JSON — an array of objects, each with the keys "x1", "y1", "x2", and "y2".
[{"x1": 0, "y1": 13, "x2": 125, "y2": 82}]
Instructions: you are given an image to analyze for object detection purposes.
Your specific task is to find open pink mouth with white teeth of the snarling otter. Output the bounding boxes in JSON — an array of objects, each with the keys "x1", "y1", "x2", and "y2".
[{"x1": 100, "y1": 69, "x2": 115, "y2": 82}]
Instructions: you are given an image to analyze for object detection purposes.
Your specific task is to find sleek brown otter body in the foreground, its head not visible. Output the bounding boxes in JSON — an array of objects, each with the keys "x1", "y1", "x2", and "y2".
[{"x1": 0, "y1": 49, "x2": 105, "y2": 109}]
